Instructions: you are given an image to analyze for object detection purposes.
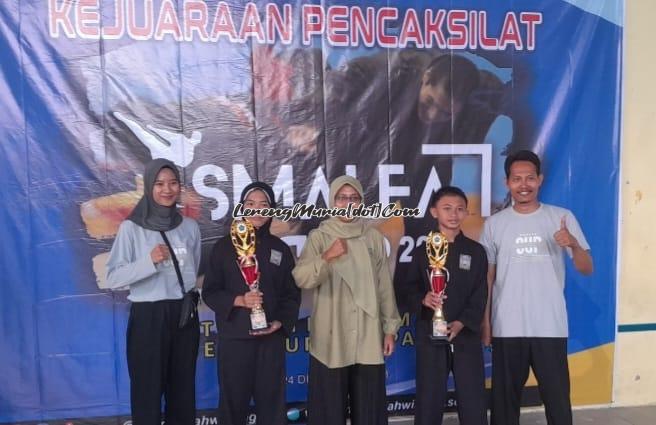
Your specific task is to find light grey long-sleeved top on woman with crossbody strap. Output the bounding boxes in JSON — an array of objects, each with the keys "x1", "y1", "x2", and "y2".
[{"x1": 107, "y1": 217, "x2": 201, "y2": 302}]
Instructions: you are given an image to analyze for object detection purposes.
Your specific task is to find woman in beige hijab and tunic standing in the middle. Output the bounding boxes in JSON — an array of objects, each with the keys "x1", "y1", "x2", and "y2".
[{"x1": 293, "y1": 176, "x2": 401, "y2": 425}]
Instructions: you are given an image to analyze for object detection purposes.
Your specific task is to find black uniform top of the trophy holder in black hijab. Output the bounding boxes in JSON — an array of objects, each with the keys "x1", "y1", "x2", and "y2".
[{"x1": 202, "y1": 221, "x2": 301, "y2": 338}]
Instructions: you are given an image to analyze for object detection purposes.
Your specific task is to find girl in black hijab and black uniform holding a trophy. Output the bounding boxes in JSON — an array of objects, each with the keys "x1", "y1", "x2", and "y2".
[{"x1": 203, "y1": 182, "x2": 301, "y2": 425}]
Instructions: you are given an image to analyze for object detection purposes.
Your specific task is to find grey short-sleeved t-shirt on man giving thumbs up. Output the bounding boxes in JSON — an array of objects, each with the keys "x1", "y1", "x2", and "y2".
[{"x1": 480, "y1": 204, "x2": 590, "y2": 337}]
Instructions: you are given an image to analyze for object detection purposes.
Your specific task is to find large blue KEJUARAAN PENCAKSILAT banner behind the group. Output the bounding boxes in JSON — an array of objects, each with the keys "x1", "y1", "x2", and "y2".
[{"x1": 0, "y1": 0, "x2": 623, "y2": 423}]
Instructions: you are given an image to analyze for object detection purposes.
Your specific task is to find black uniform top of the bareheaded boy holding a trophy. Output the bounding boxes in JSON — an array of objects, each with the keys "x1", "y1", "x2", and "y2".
[{"x1": 401, "y1": 232, "x2": 487, "y2": 344}]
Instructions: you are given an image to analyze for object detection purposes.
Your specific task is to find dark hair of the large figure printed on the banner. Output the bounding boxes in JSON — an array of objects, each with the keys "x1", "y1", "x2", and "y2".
[{"x1": 426, "y1": 54, "x2": 480, "y2": 99}]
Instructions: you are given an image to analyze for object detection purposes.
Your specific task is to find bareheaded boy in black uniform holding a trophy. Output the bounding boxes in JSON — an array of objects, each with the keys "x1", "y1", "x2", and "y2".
[{"x1": 404, "y1": 186, "x2": 487, "y2": 425}]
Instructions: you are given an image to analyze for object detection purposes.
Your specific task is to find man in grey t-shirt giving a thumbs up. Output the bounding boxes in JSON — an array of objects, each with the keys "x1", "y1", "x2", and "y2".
[{"x1": 480, "y1": 151, "x2": 593, "y2": 425}]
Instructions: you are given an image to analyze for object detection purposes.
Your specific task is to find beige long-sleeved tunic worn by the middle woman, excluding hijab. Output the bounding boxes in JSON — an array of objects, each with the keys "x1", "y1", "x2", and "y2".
[{"x1": 293, "y1": 228, "x2": 401, "y2": 368}]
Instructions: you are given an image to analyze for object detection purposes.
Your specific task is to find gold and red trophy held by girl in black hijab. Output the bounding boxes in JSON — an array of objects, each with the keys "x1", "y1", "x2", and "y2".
[{"x1": 230, "y1": 220, "x2": 269, "y2": 335}]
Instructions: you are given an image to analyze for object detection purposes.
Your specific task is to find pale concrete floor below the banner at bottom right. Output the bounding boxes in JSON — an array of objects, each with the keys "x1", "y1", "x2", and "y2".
[{"x1": 389, "y1": 406, "x2": 656, "y2": 425}]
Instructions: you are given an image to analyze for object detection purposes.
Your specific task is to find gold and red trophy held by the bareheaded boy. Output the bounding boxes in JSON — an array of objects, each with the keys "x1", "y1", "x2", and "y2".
[{"x1": 426, "y1": 232, "x2": 449, "y2": 341}]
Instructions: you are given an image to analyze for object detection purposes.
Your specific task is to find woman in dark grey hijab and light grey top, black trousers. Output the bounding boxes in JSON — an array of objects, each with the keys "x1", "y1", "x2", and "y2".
[{"x1": 107, "y1": 159, "x2": 201, "y2": 425}]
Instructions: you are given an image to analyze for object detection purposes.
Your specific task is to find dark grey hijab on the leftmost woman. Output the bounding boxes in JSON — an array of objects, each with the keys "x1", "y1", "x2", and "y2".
[{"x1": 128, "y1": 158, "x2": 182, "y2": 232}]
